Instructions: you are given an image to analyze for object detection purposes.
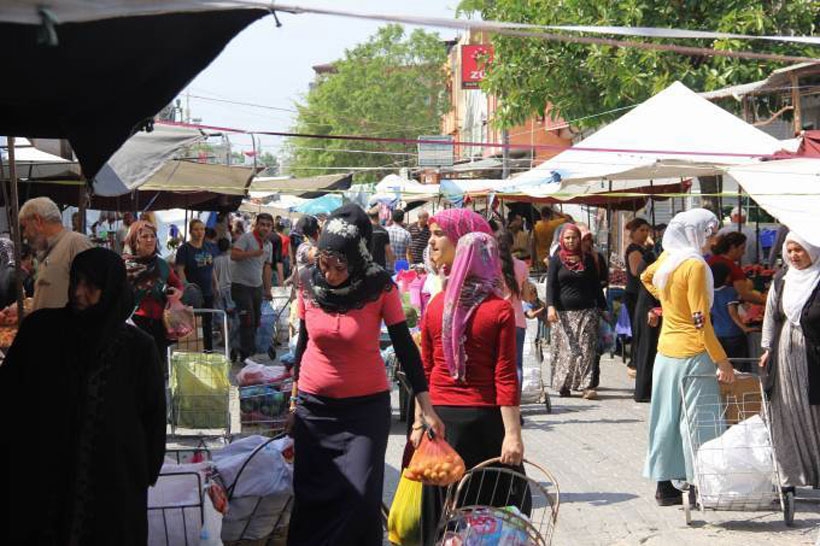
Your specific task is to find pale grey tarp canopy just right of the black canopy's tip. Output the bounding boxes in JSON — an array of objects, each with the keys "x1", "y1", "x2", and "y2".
[{"x1": 93, "y1": 124, "x2": 211, "y2": 197}]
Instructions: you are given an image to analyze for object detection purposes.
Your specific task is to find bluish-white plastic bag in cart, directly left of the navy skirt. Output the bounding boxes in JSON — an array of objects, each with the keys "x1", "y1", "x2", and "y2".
[{"x1": 213, "y1": 436, "x2": 293, "y2": 497}]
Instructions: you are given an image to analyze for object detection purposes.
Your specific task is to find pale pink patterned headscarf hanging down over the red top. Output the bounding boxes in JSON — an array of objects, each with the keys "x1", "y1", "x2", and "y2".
[{"x1": 439, "y1": 232, "x2": 503, "y2": 381}]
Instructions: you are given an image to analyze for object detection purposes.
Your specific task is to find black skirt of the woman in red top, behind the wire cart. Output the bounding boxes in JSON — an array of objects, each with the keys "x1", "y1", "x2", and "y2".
[{"x1": 421, "y1": 406, "x2": 532, "y2": 546}]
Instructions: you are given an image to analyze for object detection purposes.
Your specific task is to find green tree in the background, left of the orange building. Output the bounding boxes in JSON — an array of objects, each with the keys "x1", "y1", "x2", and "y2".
[{"x1": 287, "y1": 25, "x2": 449, "y2": 182}]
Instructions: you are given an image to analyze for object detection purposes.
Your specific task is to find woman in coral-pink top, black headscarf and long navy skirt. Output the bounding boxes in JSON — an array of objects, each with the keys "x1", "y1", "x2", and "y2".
[{"x1": 288, "y1": 205, "x2": 444, "y2": 546}]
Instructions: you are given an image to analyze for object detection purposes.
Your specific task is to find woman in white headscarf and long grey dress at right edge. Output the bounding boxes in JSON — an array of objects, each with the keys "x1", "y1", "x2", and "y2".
[{"x1": 760, "y1": 227, "x2": 820, "y2": 492}]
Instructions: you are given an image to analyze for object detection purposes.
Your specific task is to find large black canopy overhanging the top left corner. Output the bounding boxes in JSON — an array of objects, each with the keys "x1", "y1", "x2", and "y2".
[{"x1": 0, "y1": 0, "x2": 270, "y2": 180}]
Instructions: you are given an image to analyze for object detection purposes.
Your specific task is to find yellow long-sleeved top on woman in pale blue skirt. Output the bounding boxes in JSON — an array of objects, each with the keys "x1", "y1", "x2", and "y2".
[{"x1": 638, "y1": 252, "x2": 726, "y2": 363}]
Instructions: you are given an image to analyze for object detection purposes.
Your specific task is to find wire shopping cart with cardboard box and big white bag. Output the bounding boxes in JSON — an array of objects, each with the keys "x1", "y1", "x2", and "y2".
[{"x1": 680, "y1": 366, "x2": 794, "y2": 525}]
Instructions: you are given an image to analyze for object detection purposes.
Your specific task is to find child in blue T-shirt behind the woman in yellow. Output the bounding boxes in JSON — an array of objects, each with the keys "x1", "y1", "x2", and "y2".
[{"x1": 710, "y1": 262, "x2": 751, "y2": 372}]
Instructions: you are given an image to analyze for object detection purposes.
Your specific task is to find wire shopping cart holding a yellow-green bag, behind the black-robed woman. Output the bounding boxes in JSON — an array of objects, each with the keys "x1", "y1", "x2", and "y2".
[{"x1": 168, "y1": 309, "x2": 231, "y2": 439}]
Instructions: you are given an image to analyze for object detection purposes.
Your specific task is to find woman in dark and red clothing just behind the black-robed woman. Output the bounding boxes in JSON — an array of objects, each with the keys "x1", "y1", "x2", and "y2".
[{"x1": 122, "y1": 220, "x2": 183, "y2": 361}]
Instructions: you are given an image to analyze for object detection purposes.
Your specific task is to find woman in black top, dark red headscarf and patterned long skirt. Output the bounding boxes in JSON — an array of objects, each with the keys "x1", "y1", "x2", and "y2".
[{"x1": 546, "y1": 224, "x2": 606, "y2": 400}]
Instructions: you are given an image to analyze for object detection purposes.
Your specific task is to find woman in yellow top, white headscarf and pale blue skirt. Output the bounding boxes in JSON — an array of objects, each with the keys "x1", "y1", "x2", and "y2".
[{"x1": 641, "y1": 209, "x2": 734, "y2": 506}]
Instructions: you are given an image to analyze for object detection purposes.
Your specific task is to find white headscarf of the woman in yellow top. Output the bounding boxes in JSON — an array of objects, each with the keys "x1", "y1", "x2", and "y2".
[{"x1": 652, "y1": 209, "x2": 718, "y2": 307}]
